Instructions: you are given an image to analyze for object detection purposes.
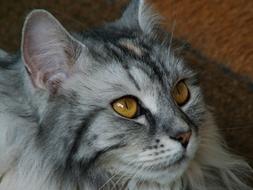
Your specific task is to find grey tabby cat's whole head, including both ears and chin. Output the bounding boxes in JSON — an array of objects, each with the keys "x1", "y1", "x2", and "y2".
[{"x1": 22, "y1": 0, "x2": 206, "y2": 186}]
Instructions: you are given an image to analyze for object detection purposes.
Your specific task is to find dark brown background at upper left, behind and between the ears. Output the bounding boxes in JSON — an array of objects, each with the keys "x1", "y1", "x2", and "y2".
[{"x1": 0, "y1": 0, "x2": 127, "y2": 52}]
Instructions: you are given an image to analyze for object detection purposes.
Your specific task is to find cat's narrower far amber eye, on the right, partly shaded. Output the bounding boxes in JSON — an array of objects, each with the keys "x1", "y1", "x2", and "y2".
[{"x1": 172, "y1": 80, "x2": 190, "y2": 106}]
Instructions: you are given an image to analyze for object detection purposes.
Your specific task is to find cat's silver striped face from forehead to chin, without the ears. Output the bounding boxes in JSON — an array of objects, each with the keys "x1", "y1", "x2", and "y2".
[{"x1": 64, "y1": 39, "x2": 204, "y2": 182}]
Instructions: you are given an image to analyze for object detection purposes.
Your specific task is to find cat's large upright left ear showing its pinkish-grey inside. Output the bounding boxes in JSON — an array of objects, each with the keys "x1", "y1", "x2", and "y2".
[{"x1": 21, "y1": 10, "x2": 82, "y2": 93}]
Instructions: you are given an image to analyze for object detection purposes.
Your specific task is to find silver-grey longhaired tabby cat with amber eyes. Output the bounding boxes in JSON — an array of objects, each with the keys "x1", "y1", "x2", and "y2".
[{"x1": 0, "y1": 0, "x2": 252, "y2": 190}]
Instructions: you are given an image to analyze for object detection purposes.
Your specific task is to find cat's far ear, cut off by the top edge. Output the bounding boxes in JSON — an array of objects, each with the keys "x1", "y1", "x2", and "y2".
[{"x1": 119, "y1": 0, "x2": 160, "y2": 34}]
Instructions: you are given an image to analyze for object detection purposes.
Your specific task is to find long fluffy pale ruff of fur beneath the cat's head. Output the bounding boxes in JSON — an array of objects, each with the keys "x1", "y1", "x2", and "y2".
[{"x1": 0, "y1": 109, "x2": 252, "y2": 190}]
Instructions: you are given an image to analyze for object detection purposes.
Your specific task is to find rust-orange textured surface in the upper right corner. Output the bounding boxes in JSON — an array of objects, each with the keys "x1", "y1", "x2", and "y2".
[{"x1": 151, "y1": 0, "x2": 253, "y2": 79}]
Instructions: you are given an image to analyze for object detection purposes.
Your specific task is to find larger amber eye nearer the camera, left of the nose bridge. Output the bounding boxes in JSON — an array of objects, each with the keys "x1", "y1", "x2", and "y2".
[{"x1": 112, "y1": 96, "x2": 138, "y2": 119}]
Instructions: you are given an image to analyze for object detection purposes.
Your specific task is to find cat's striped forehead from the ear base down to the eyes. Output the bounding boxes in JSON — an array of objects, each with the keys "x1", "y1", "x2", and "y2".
[{"x1": 68, "y1": 38, "x2": 193, "y2": 113}]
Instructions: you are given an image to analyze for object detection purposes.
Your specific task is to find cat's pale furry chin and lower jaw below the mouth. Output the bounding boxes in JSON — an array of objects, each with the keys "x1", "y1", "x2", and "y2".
[{"x1": 104, "y1": 138, "x2": 198, "y2": 186}]
